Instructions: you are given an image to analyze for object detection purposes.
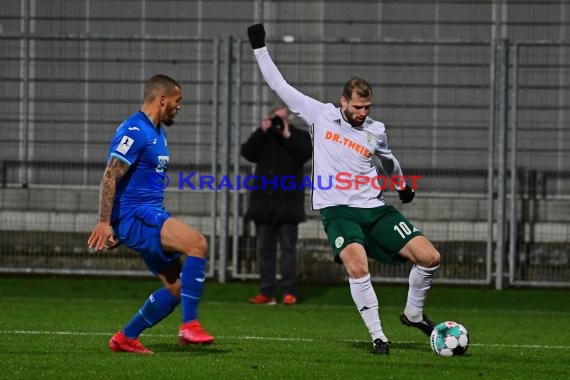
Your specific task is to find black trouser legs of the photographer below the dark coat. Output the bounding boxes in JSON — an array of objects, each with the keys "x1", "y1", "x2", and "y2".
[{"x1": 255, "y1": 223, "x2": 299, "y2": 297}]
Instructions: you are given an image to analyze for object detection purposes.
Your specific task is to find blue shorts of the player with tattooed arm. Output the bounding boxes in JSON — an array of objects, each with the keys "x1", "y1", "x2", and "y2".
[{"x1": 113, "y1": 206, "x2": 181, "y2": 274}]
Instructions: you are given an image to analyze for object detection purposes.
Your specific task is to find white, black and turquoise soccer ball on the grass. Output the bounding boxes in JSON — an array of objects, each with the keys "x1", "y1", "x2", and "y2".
[{"x1": 429, "y1": 321, "x2": 469, "y2": 356}]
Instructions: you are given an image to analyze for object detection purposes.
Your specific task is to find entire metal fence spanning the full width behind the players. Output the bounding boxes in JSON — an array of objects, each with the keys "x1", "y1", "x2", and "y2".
[{"x1": 0, "y1": 35, "x2": 570, "y2": 288}]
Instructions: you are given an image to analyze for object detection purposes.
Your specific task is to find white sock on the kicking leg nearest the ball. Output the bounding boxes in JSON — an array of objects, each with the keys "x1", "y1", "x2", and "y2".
[{"x1": 404, "y1": 265, "x2": 439, "y2": 322}]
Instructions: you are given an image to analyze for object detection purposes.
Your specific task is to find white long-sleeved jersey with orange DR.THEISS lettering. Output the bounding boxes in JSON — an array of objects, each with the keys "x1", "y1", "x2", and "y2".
[{"x1": 254, "y1": 47, "x2": 405, "y2": 210}]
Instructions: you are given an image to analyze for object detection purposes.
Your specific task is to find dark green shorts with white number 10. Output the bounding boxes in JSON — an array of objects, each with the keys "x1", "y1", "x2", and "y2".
[{"x1": 321, "y1": 205, "x2": 422, "y2": 264}]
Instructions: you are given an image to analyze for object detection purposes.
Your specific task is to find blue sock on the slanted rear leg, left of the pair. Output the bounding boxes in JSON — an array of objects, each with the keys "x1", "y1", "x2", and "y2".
[{"x1": 123, "y1": 288, "x2": 180, "y2": 338}]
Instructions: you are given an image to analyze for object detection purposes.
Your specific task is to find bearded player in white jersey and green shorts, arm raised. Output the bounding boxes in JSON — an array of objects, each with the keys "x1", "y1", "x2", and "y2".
[{"x1": 247, "y1": 24, "x2": 440, "y2": 354}]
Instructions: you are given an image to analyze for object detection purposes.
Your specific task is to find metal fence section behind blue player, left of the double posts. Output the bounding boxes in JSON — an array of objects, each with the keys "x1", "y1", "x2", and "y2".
[{"x1": 0, "y1": 35, "x2": 221, "y2": 275}]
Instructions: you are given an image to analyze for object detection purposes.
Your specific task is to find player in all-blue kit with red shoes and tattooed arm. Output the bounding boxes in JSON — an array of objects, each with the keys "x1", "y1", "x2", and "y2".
[{"x1": 87, "y1": 74, "x2": 214, "y2": 354}]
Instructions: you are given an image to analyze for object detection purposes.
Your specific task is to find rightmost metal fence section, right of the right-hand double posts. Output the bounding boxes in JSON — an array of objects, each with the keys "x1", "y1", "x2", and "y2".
[{"x1": 506, "y1": 41, "x2": 570, "y2": 286}]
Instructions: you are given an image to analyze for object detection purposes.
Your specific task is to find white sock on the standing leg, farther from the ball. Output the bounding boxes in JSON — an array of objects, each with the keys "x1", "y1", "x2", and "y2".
[{"x1": 348, "y1": 274, "x2": 388, "y2": 342}]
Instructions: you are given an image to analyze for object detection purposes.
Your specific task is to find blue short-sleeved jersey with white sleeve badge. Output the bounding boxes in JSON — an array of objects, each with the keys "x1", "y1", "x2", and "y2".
[{"x1": 107, "y1": 111, "x2": 168, "y2": 220}]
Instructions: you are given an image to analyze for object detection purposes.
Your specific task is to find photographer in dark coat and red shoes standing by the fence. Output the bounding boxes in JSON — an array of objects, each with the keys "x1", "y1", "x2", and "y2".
[{"x1": 241, "y1": 106, "x2": 312, "y2": 305}]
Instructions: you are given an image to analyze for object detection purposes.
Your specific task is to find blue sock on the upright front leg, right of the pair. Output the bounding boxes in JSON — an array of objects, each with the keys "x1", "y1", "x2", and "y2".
[{"x1": 180, "y1": 256, "x2": 206, "y2": 323}]
